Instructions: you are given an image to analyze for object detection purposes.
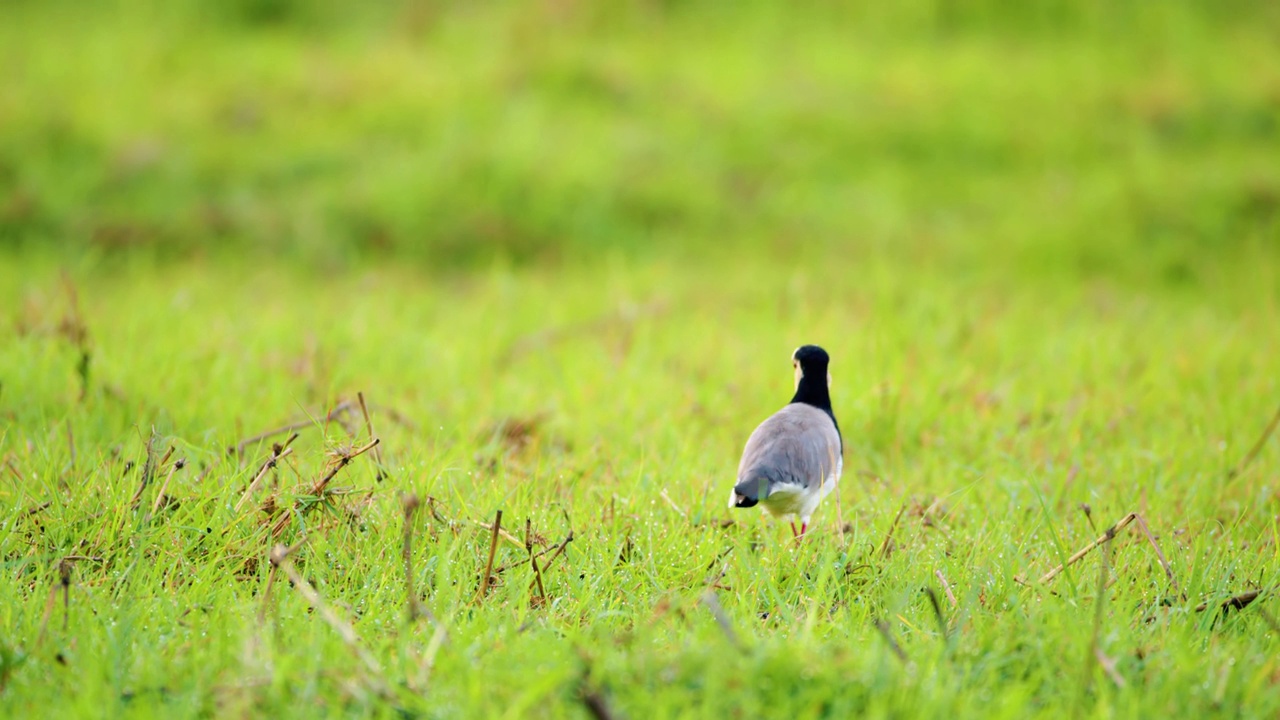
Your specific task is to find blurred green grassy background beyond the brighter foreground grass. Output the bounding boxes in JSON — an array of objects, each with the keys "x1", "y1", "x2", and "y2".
[{"x1": 0, "y1": 0, "x2": 1280, "y2": 287}]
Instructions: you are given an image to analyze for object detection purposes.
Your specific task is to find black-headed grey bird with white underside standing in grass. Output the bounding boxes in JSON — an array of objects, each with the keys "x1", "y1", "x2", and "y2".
[{"x1": 730, "y1": 345, "x2": 845, "y2": 542}]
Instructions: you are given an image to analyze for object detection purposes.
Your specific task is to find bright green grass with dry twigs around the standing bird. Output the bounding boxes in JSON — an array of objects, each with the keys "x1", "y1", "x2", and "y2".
[{"x1": 0, "y1": 254, "x2": 1280, "y2": 716}]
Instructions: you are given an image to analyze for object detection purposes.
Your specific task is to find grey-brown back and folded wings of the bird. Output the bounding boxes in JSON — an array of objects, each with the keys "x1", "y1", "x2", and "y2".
[{"x1": 737, "y1": 402, "x2": 841, "y2": 488}]
